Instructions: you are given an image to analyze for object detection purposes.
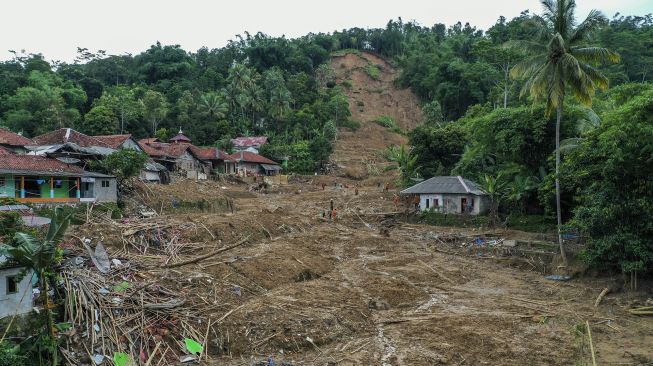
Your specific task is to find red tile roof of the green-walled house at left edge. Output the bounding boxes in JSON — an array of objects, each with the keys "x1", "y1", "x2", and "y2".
[{"x1": 0, "y1": 155, "x2": 83, "y2": 175}]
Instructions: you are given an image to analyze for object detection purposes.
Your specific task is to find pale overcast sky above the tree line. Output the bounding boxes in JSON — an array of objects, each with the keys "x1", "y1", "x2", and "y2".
[{"x1": 0, "y1": 0, "x2": 653, "y2": 62}]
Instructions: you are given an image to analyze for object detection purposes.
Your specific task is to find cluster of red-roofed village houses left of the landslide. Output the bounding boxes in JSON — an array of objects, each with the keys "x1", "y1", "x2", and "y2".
[{"x1": 0, "y1": 128, "x2": 281, "y2": 204}]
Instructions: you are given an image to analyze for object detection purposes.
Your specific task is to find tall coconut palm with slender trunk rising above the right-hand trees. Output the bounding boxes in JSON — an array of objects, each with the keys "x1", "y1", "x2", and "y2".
[{"x1": 507, "y1": 0, "x2": 619, "y2": 263}]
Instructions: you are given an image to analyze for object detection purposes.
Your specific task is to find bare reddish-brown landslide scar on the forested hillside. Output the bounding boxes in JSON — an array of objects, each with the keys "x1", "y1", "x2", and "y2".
[{"x1": 331, "y1": 52, "x2": 422, "y2": 178}]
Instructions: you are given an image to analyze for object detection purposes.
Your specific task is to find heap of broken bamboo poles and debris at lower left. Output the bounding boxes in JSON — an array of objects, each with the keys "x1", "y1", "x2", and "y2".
[{"x1": 61, "y1": 226, "x2": 251, "y2": 365}]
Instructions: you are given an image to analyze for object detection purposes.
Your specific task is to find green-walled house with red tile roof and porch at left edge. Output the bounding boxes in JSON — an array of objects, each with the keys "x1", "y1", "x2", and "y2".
[{"x1": 0, "y1": 155, "x2": 83, "y2": 203}]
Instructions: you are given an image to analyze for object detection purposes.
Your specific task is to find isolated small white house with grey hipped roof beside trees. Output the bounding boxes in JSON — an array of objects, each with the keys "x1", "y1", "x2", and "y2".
[{"x1": 400, "y1": 176, "x2": 488, "y2": 215}]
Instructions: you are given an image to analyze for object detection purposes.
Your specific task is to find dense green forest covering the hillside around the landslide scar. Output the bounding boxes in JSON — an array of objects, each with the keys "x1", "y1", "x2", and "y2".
[{"x1": 0, "y1": 1, "x2": 653, "y2": 272}]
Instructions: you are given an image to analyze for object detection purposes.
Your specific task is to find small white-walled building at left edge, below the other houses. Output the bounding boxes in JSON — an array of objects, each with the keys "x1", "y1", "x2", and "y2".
[{"x1": 0, "y1": 255, "x2": 33, "y2": 319}]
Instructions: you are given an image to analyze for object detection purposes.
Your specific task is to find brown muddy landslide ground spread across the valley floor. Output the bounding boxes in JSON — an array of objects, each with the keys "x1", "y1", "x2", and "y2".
[{"x1": 69, "y1": 177, "x2": 653, "y2": 365}]
